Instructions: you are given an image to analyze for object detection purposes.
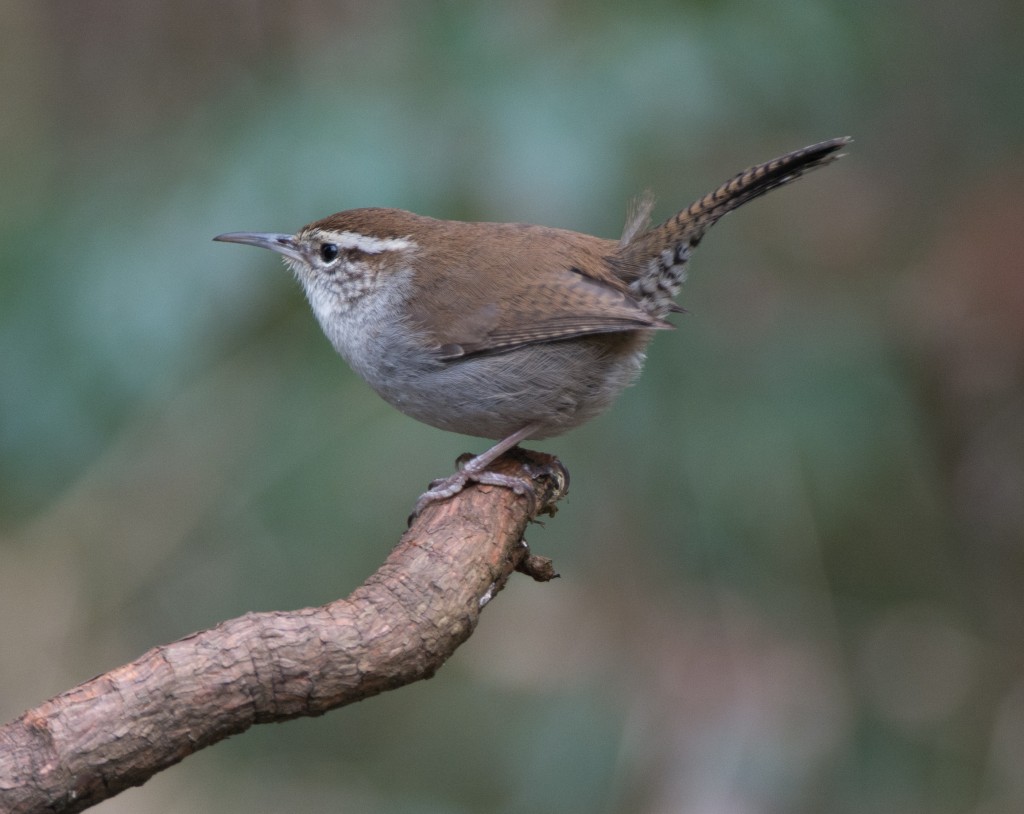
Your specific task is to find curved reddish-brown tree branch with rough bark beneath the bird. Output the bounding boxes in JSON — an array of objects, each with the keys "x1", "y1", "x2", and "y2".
[{"x1": 0, "y1": 449, "x2": 568, "y2": 814}]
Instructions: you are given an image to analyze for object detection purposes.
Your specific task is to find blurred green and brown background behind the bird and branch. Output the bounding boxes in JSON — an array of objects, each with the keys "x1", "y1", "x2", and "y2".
[{"x1": 0, "y1": 0, "x2": 1024, "y2": 814}]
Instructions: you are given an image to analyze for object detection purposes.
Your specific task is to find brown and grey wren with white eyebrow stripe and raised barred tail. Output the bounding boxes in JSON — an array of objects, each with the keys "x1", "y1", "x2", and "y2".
[{"x1": 214, "y1": 138, "x2": 850, "y2": 512}]
